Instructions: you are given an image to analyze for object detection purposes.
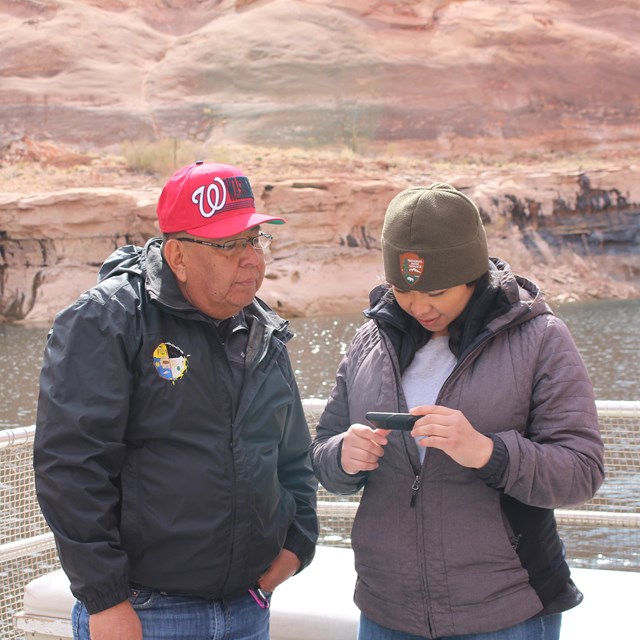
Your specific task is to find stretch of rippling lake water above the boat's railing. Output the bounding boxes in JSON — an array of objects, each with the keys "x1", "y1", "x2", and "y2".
[{"x1": 0, "y1": 300, "x2": 640, "y2": 429}]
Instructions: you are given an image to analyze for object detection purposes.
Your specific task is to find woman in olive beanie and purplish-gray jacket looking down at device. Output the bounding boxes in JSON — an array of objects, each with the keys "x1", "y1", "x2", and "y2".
[{"x1": 312, "y1": 183, "x2": 604, "y2": 640}]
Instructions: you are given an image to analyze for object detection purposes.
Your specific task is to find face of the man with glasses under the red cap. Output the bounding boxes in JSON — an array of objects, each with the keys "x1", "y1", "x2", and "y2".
[{"x1": 170, "y1": 227, "x2": 265, "y2": 320}]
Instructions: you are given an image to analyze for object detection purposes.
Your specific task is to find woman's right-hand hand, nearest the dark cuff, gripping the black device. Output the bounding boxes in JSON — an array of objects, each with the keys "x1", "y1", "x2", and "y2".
[{"x1": 411, "y1": 405, "x2": 493, "y2": 469}]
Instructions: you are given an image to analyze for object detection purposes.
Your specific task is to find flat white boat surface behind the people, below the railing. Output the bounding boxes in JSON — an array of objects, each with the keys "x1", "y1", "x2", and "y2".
[{"x1": 15, "y1": 546, "x2": 640, "y2": 640}]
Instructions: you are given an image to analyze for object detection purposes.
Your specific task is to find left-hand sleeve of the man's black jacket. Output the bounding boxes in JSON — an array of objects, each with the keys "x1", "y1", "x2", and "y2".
[{"x1": 34, "y1": 293, "x2": 132, "y2": 613}]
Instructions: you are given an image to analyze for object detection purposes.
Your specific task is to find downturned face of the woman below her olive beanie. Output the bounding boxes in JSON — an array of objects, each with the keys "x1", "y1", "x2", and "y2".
[{"x1": 393, "y1": 284, "x2": 475, "y2": 336}]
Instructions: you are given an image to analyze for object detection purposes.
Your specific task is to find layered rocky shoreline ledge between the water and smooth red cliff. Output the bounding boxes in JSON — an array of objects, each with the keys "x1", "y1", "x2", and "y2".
[{"x1": 0, "y1": 145, "x2": 640, "y2": 322}]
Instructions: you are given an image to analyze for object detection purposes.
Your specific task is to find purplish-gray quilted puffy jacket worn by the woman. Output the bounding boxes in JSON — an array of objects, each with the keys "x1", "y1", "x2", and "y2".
[{"x1": 312, "y1": 259, "x2": 604, "y2": 638}]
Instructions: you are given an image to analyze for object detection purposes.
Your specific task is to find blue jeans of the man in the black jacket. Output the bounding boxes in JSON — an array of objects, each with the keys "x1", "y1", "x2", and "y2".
[{"x1": 71, "y1": 589, "x2": 269, "y2": 640}]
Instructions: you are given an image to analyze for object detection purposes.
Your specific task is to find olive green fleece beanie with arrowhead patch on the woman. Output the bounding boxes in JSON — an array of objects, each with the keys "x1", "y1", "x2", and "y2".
[{"x1": 382, "y1": 182, "x2": 489, "y2": 292}]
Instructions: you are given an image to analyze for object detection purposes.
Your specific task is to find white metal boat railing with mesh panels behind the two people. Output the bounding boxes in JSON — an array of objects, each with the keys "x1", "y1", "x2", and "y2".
[{"x1": 0, "y1": 398, "x2": 640, "y2": 640}]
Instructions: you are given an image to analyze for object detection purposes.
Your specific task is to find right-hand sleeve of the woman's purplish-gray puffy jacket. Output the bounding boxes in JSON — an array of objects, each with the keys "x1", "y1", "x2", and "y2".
[{"x1": 497, "y1": 316, "x2": 604, "y2": 509}]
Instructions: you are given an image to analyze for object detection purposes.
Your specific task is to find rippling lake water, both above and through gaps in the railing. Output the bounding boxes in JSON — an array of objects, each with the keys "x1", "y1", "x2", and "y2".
[{"x1": 0, "y1": 300, "x2": 640, "y2": 570}]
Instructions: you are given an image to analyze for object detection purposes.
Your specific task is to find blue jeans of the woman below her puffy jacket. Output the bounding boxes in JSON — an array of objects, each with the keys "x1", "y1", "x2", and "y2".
[{"x1": 358, "y1": 613, "x2": 562, "y2": 640}]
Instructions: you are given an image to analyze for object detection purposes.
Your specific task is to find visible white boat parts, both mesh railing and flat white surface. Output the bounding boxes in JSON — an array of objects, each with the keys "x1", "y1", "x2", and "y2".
[{"x1": 5, "y1": 399, "x2": 640, "y2": 640}]
